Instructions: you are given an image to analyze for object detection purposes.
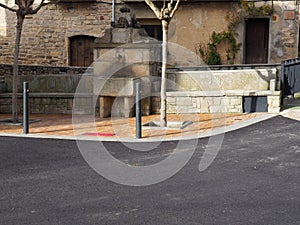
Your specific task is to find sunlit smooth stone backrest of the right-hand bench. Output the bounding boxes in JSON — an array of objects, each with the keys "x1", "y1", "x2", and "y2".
[{"x1": 168, "y1": 68, "x2": 280, "y2": 92}]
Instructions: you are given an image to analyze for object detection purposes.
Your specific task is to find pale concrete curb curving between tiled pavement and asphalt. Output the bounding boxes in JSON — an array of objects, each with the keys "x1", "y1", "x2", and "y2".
[{"x1": 0, "y1": 114, "x2": 278, "y2": 142}]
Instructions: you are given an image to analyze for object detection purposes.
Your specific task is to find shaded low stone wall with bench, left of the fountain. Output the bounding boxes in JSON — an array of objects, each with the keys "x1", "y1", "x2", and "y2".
[{"x1": 0, "y1": 65, "x2": 92, "y2": 114}]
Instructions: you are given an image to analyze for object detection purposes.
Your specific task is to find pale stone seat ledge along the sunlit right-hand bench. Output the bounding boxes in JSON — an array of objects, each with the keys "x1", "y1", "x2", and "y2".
[{"x1": 166, "y1": 90, "x2": 281, "y2": 97}]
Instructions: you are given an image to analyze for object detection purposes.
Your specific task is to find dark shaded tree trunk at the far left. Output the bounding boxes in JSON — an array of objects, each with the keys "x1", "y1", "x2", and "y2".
[{"x1": 12, "y1": 12, "x2": 24, "y2": 123}]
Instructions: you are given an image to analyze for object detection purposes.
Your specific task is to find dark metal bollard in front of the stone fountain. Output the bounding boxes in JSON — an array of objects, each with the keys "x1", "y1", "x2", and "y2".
[{"x1": 135, "y1": 81, "x2": 142, "y2": 138}]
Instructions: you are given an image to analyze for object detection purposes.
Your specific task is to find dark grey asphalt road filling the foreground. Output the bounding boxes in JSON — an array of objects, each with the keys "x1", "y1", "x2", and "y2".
[{"x1": 0, "y1": 116, "x2": 300, "y2": 225}]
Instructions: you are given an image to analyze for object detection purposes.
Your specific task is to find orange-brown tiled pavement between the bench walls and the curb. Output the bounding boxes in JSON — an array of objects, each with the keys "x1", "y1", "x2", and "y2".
[{"x1": 0, "y1": 113, "x2": 266, "y2": 140}]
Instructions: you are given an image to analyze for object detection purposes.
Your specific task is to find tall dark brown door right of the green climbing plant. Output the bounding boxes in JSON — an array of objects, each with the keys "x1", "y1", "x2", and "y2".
[{"x1": 245, "y1": 18, "x2": 269, "y2": 64}]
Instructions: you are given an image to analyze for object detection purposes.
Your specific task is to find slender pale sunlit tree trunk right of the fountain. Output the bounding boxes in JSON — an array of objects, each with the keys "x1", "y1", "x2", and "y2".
[{"x1": 160, "y1": 20, "x2": 169, "y2": 127}]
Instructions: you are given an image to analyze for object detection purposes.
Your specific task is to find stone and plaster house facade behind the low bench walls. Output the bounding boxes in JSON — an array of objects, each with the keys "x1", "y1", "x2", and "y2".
[{"x1": 0, "y1": 0, "x2": 299, "y2": 66}]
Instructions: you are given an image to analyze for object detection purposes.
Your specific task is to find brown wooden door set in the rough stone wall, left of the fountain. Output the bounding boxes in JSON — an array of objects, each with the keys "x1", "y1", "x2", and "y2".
[{"x1": 70, "y1": 35, "x2": 95, "y2": 67}]
